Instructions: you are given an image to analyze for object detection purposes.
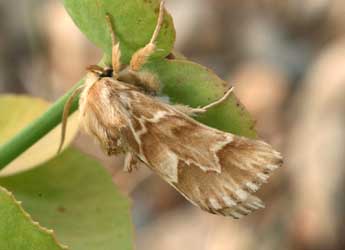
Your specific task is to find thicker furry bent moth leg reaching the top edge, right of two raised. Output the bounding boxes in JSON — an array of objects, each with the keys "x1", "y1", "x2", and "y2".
[{"x1": 129, "y1": 1, "x2": 164, "y2": 71}]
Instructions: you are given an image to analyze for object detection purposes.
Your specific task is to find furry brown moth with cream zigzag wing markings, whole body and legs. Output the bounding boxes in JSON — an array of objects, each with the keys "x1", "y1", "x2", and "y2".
[{"x1": 60, "y1": 2, "x2": 282, "y2": 218}]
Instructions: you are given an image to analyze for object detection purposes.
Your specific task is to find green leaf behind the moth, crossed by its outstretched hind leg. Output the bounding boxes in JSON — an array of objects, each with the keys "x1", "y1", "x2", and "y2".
[{"x1": 146, "y1": 59, "x2": 256, "y2": 138}]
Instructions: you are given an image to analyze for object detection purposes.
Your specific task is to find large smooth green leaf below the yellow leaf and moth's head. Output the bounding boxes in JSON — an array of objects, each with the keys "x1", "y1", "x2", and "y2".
[{"x1": 0, "y1": 149, "x2": 132, "y2": 250}]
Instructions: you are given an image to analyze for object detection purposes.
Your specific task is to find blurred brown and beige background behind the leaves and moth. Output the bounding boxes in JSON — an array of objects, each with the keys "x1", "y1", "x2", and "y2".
[{"x1": 0, "y1": 0, "x2": 345, "y2": 250}]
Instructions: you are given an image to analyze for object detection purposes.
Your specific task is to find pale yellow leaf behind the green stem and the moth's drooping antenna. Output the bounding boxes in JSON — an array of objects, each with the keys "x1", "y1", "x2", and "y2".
[{"x1": 0, "y1": 95, "x2": 79, "y2": 176}]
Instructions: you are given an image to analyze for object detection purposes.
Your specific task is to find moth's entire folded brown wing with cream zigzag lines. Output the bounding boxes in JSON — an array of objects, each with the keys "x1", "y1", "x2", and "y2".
[{"x1": 120, "y1": 91, "x2": 282, "y2": 218}]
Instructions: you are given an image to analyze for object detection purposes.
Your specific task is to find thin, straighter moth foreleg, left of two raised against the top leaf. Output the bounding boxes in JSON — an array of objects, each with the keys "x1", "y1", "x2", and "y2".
[{"x1": 106, "y1": 15, "x2": 121, "y2": 79}]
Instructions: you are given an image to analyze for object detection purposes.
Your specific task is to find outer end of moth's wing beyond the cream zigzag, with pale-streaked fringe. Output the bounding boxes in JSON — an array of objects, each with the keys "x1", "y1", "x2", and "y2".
[{"x1": 174, "y1": 137, "x2": 282, "y2": 218}]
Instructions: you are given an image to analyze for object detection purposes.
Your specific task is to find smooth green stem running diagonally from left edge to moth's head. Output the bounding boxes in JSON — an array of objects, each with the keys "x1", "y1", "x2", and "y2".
[{"x1": 0, "y1": 80, "x2": 83, "y2": 170}]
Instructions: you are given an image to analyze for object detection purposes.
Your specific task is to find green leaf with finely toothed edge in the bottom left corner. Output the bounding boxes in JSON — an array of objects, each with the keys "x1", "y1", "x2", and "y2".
[{"x1": 0, "y1": 186, "x2": 66, "y2": 250}]
